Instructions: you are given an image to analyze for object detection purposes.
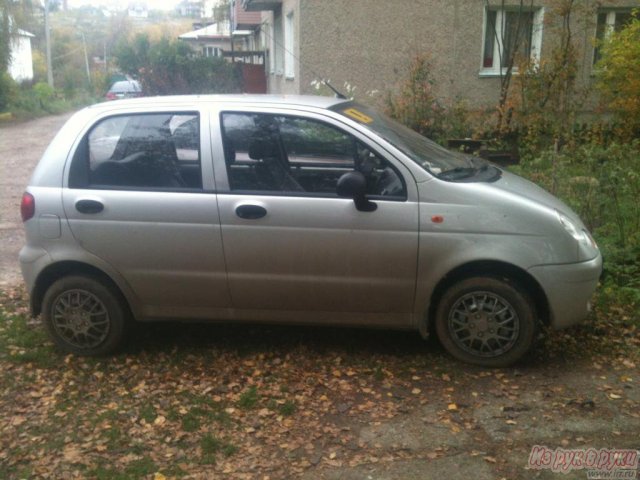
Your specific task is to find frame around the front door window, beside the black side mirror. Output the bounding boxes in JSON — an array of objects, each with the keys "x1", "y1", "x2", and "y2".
[{"x1": 217, "y1": 107, "x2": 411, "y2": 202}]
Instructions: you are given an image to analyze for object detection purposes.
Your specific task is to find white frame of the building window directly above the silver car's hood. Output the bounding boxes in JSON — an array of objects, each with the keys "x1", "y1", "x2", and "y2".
[{"x1": 479, "y1": 5, "x2": 545, "y2": 77}]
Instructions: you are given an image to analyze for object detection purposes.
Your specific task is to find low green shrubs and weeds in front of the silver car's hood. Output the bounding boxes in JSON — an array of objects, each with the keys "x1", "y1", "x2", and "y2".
[{"x1": 514, "y1": 141, "x2": 640, "y2": 322}]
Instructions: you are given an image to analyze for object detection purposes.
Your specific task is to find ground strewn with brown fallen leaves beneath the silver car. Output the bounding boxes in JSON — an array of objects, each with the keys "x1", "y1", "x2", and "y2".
[{"x1": 0, "y1": 289, "x2": 640, "y2": 479}]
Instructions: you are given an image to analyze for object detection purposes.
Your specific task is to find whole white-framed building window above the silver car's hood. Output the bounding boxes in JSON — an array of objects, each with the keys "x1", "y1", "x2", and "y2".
[{"x1": 481, "y1": 7, "x2": 543, "y2": 75}]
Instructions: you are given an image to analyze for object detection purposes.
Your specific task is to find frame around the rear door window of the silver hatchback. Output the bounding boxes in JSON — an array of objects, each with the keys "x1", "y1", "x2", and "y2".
[{"x1": 64, "y1": 109, "x2": 204, "y2": 193}]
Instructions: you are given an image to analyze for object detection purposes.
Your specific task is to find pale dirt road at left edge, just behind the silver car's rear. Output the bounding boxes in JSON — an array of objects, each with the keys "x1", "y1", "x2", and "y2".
[{"x1": 0, "y1": 114, "x2": 71, "y2": 287}]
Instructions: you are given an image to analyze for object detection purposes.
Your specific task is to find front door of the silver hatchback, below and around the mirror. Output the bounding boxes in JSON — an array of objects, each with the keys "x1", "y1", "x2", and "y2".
[{"x1": 212, "y1": 110, "x2": 418, "y2": 324}]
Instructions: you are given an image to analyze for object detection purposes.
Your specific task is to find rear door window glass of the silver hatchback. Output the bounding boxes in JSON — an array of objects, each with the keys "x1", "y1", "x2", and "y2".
[{"x1": 69, "y1": 113, "x2": 202, "y2": 190}]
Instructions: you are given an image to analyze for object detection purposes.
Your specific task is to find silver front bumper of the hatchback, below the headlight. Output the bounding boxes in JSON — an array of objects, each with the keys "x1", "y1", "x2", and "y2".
[{"x1": 529, "y1": 253, "x2": 602, "y2": 329}]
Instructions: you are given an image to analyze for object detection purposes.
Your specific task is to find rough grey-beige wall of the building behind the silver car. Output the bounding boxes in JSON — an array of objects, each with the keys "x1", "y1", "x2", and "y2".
[{"x1": 272, "y1": 0, "x2": 640, "y2": 108}]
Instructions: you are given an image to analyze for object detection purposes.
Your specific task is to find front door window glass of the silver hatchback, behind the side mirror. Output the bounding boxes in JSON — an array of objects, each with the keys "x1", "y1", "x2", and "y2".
[{"x1": 222, "y1": 113, "x2": 406, "y2": 200}]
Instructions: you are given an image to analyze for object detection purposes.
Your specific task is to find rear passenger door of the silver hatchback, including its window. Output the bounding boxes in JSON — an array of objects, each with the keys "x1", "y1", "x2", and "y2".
[{"x1": 63, "y1": 110, "x2": 230, "y2": 318}]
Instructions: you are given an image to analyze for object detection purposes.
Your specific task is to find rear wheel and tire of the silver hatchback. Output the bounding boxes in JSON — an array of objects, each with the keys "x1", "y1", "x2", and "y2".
[{"x1": 42, "y1": 275, "x2": 129, "y2": 356}]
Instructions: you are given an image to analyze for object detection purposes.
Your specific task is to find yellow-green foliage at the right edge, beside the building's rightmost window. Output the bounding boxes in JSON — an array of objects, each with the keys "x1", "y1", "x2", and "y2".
[{"x1": 596, "y1": 11, "x2": 640, "y2": 137}]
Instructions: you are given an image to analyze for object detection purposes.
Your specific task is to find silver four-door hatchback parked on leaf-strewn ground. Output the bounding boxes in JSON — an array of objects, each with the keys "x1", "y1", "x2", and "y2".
[{"x1": 20, "y1": 95, "x2": 602, "y2": 367}]
